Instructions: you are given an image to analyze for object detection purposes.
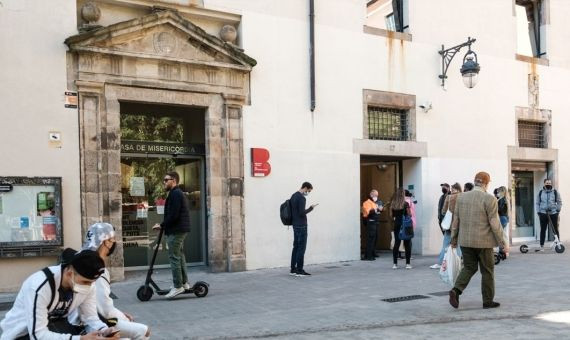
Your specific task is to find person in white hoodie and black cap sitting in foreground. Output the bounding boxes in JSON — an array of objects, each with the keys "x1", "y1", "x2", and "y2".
[{"x1": 0, "y1": 249, "x2": 119, "y2": 340}]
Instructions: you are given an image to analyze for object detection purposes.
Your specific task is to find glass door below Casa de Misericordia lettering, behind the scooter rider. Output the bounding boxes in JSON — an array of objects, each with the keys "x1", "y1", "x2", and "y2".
[{"x1": 121, "y1": 155, "x2": 206, "y2": 269}]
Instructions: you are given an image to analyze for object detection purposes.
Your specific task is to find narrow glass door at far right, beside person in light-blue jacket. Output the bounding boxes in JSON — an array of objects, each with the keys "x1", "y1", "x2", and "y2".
[{"x1": 513, "y1": 171, "x2": 535, "y2": 238}]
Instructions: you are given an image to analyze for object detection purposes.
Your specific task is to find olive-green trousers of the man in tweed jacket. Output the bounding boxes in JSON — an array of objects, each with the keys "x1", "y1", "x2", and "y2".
[{"x1": 454, "y1": 247, "x2": 495, "y2": 304}]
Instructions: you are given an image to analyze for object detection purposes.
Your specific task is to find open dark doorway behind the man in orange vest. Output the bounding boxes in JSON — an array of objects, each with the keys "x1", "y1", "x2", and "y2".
[{"x1": 360, "y1": 157, "x2": 402, "y2": 254}]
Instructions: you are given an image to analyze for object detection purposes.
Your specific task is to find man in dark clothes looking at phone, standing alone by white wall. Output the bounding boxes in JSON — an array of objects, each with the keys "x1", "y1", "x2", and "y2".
[{"x1": 289, "y1": 182, "x2": 317, "y2": 276}]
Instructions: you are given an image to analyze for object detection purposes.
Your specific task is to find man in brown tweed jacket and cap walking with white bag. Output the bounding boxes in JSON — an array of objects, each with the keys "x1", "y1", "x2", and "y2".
[{"x1": 449, "y1": 172, "x2": 509, "y2": 308}]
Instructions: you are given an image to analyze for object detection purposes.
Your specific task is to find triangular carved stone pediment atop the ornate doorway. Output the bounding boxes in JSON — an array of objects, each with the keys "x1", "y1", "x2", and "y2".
[{"x1": 65, "y1": 11, "x2": 257, "y2": 72}]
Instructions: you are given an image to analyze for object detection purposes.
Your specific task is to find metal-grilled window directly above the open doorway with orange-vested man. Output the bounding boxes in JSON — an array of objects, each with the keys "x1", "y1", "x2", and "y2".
[{"x1": 368, "y1": 106, "x2": 409, "y2": 140}]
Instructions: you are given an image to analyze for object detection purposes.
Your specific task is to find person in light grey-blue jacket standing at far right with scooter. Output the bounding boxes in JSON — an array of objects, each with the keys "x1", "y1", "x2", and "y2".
[{"x1": 536, "y1": 178, "x2": 562, "y2": 251}]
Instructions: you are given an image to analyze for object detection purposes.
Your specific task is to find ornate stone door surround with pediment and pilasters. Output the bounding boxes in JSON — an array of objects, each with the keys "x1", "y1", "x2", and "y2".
[{"x1": 65, "y1": 11, "x2": 256, "y2": 279}]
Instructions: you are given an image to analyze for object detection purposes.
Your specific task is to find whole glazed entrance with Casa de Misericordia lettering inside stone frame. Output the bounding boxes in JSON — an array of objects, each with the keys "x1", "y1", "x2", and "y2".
[{"x1": 120, "y1": 102, "x2": 207, "y2": 270}]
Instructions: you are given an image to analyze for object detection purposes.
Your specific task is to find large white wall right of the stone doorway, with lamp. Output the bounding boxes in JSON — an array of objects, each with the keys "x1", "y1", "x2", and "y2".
[{"x1": 205, "y1": 0, "x2": 570, "y2": 269}]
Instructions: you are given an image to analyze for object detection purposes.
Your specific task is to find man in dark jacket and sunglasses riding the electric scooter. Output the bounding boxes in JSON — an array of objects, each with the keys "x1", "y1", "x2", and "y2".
[{"x1": 152, "y1": 171, "x2": 190, "y2": 299}]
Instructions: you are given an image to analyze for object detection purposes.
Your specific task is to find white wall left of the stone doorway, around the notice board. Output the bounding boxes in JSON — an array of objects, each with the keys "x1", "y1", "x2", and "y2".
[{"x1": 0, "y1": 0, "x2": 81, "y2": 290}]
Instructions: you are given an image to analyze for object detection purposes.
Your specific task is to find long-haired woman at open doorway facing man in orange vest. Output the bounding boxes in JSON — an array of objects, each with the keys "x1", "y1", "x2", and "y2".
[{"x1": 390, "y1": 188, "x2": 413, "y2": 269}]
